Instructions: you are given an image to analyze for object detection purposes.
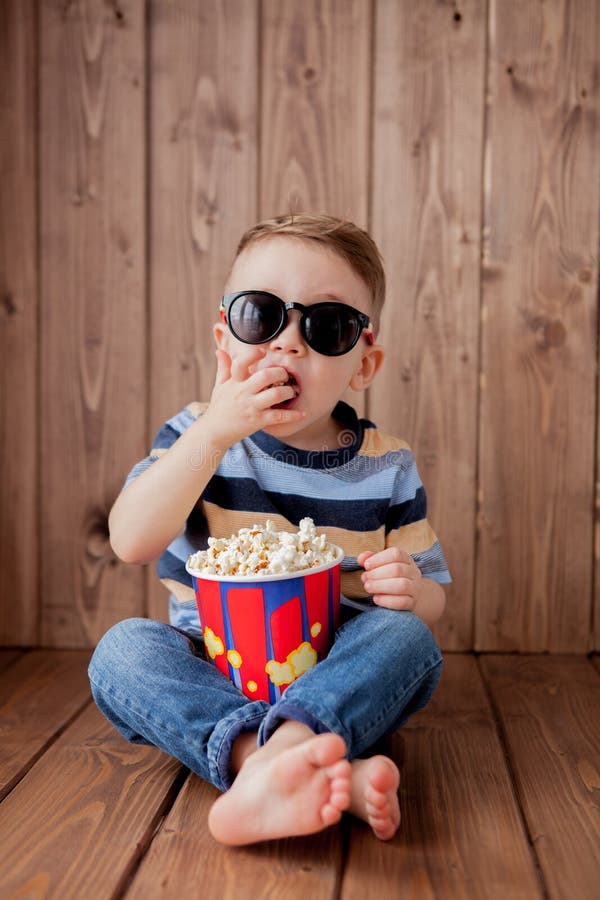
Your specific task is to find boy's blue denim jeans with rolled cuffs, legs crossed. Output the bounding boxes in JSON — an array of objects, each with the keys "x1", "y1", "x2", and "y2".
[{"x1": 89, "y1": 607, "x2": 442, "y2": 790}]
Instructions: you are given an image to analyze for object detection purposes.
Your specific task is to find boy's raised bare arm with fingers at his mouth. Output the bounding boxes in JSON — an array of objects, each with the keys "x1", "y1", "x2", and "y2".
[{"x1": 108, "y1": 347, "x2": 305, "y2": 563}]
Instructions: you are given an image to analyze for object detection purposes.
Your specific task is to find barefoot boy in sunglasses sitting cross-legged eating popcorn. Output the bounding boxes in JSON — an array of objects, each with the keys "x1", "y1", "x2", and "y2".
[{"x1": 90, "y1": 215, "x2": 450, "y2": 844}]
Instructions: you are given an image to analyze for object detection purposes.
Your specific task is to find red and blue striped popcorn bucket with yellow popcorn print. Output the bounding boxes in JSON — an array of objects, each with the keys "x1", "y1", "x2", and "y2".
[{"x1": 186, "y1": 547, "x2": 344, "y2": 703}]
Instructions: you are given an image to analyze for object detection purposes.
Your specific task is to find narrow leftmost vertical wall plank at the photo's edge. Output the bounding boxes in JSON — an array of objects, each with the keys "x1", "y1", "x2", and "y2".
[{"x1": 0, "y1": 0, "x2": 39, "y2": 646}]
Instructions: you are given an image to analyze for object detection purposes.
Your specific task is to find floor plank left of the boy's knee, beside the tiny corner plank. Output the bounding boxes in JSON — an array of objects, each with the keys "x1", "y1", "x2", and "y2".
[{"x1": 0, "y1": 650, "x2": 90, "y2": 800}]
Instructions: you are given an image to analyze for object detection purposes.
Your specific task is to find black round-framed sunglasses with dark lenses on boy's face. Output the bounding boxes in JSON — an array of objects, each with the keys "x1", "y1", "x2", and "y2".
[{"x1": 219, "y1": 291, "x2": 375, "y2": 356}]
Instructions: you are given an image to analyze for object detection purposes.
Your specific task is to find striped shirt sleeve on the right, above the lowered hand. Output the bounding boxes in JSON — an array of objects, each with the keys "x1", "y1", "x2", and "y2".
[{"x1": 385, "y1": 451, "x2": 452, "y2": 584}]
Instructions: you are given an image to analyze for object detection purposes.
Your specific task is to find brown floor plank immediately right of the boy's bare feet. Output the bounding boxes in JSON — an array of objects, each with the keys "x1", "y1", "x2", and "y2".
[{"x1": 340, "y1": 654, "x2": 540, "y2": 900}]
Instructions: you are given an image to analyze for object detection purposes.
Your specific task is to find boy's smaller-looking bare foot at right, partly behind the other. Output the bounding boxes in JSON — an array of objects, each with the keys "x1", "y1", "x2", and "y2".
[{"x1": 348, "y1": 756, "x2": 400, "y2": 841}]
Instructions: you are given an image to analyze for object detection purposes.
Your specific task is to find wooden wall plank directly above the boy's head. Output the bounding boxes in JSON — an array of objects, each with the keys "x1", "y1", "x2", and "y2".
[{"x1": 259, "y1": 0, "x2": 371, "y2": 228}]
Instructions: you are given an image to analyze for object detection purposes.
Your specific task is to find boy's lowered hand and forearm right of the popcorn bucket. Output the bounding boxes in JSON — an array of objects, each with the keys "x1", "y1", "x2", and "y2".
[{"x1": 357, "y1": 547, "x2": 446, "y2": 627}]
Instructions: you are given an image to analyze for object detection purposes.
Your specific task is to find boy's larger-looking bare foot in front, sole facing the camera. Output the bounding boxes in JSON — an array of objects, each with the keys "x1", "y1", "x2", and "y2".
[{"x1": 208, "y1": 729, "x2": 351, "y2": 844}]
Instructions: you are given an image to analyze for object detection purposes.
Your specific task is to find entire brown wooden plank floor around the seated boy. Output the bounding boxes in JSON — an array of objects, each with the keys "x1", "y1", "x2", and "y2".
[{"x1": 0, "y1": 650, "x2": 600, "y2": 900}]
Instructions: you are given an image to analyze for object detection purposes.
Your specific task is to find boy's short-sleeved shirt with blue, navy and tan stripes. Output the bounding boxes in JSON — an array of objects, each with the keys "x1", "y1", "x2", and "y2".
[{"x1": 125, "y1": 402, "x2": 451, "y2": 633}]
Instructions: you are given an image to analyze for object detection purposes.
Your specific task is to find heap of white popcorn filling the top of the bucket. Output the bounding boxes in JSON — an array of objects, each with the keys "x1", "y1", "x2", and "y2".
[{"x1": 188, "y1": 517, "x2": 338, "y2": 577}]
